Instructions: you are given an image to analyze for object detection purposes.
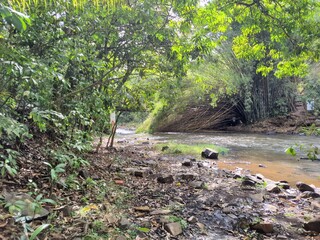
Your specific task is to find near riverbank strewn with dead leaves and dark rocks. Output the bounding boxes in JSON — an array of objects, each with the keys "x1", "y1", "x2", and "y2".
[{"x1": 0, "y1": 132, "x2": 320, "y2": 240}]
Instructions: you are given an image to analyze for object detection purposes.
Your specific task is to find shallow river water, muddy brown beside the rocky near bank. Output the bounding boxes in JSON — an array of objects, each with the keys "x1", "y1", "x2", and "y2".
[{"x1": 117, "y1": 129, "x2": 320, "y2": 187}]
